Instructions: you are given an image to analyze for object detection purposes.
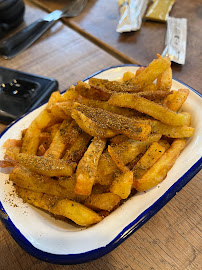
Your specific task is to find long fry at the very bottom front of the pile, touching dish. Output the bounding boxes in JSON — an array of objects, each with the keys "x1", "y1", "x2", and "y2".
[{"x1": 17, "y1": 187, "x2": 102, "y2": 226}]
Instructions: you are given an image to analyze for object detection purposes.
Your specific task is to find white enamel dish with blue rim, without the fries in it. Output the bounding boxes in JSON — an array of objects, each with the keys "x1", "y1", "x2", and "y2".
[{"x1": 0, "y1": 65, "x2": 202, "y2": 264}]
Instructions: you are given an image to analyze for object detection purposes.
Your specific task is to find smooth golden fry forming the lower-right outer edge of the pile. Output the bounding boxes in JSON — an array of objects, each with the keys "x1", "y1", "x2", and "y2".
[{"x1": 134, "y1": 139, "x2": 186, "y2": 191}]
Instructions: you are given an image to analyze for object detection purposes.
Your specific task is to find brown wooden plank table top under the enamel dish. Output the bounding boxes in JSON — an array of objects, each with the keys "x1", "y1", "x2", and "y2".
[{"x1": 0, "y1": 0, "x2": 202, "y2": 270}]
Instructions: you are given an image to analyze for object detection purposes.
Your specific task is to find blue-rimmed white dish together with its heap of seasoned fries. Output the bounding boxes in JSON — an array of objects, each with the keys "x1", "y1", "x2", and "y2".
[{"x1": 0, "y1": 55, "x2": 202, "y2": 264}]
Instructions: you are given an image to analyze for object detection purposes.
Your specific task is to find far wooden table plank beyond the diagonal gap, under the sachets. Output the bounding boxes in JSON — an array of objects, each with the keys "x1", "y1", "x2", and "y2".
[{"x1": 33, "y1": 0, "x2": 202, "y2": 91}]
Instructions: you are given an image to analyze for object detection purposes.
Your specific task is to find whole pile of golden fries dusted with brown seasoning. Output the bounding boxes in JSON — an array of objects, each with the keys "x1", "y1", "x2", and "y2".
[{"x1": 0, "y1": 56, "x2": 194, "y2": 226}]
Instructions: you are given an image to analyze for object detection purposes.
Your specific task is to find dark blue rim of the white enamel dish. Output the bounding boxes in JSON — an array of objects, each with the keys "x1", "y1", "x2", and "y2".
[{"x1": 0, "y1": 64, "x2": 202, "y2": 265}]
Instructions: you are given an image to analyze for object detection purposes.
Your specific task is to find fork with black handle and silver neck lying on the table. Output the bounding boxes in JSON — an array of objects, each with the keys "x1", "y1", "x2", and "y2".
[{"x1": 0, "y1": 0, "x2": 88, "y2": 59}]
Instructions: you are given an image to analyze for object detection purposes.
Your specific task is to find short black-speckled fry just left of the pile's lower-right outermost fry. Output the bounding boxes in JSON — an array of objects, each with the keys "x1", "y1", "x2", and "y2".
[{"x1": 132, "y1": 142, "x2": 166, "y2": 179}]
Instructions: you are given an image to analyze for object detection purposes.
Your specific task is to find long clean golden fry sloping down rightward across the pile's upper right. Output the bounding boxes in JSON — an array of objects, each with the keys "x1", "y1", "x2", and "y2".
[{"x1": 108, "y1": 93, "x2": 189, "y2": 126}]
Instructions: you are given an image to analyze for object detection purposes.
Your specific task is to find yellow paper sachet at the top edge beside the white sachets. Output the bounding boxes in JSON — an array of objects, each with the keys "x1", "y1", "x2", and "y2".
[{"x1": 145, "y1": 0, "x2": 175, "y2": 22}]
